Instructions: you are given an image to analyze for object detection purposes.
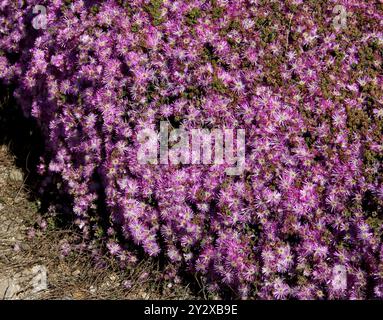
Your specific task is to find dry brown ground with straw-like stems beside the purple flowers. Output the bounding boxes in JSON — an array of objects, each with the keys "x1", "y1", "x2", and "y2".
[{"x1": 0, "y1": 145, "x2": 195, "y2": 299}]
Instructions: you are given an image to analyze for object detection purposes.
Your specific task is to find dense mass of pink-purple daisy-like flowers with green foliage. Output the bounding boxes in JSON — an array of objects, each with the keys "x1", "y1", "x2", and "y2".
[{"x1": 0, "y1": 0, "x2": 383, "y2": 299}]
